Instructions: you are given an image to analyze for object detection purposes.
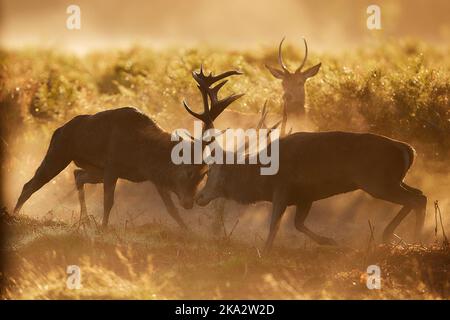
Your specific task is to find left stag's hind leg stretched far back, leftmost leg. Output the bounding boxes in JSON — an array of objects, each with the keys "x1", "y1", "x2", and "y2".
[{"x1": 13, "y1": 149, "x2": 71, "y2": 214}]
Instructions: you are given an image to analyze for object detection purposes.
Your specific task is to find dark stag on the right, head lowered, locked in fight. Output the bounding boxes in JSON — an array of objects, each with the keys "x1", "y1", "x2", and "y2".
[{"x1": 185, "y1": 74, "x2": 427, "y2": 251}]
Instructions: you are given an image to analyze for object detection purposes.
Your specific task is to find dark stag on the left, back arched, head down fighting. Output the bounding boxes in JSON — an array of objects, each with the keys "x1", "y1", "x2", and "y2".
[{"x1": 14, "y1": 106, "x2": 215, "y2": 229}]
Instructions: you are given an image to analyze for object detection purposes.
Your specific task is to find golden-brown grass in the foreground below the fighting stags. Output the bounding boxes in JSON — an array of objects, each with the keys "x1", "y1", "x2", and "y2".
[{"x1": 2, "y1": 215, "x2": 450, "y2": 299}]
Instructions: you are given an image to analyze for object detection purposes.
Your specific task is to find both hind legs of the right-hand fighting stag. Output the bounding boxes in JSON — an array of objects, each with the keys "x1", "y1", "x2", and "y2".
[{"x1": 364, "y1": 183, "x2": 427, "y2": 242}]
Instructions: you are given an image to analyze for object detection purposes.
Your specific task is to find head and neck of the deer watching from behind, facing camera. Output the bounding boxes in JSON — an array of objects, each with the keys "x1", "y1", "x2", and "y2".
[{"x1": 266, "y1": 38, "x2": 322, "y2": 118}]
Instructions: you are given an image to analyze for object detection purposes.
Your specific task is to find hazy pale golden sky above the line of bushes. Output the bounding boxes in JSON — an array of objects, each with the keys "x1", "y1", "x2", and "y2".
[{"x1": 0, "y1": 0, "x2": 450, "y2": 52}]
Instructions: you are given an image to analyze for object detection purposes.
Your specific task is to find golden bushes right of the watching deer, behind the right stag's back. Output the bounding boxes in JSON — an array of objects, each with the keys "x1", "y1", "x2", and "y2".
[{"x1": 308, "y1": 42, "x2": 450, "y2": 164}]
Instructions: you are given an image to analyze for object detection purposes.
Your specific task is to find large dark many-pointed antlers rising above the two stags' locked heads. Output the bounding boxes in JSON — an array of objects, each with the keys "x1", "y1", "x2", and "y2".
[{"x1": 183, "y1": 65, "x2": 244, "y2": 129}]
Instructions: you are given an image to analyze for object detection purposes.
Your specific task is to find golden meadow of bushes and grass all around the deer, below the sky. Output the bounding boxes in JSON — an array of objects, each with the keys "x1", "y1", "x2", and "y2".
[{"x1": 0, "y1": 39, "x2": 450, "y2": 299}]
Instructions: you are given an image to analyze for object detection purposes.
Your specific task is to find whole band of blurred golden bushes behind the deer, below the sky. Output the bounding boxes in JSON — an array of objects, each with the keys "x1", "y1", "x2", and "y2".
[{"x1": 0, "y1": 40, "x2": 450, "y2": 164}]
